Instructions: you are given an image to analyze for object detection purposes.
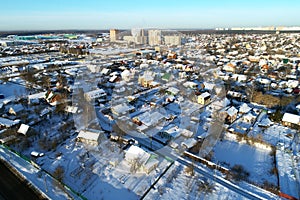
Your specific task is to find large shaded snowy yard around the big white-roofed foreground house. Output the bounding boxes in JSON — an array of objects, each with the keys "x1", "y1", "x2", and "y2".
[{"x1": 37, "y1": 136, "x2": 170, "y2": 199}]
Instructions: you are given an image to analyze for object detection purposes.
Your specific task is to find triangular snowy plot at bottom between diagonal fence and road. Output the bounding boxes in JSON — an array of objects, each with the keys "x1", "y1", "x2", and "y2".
[{"x1": 145, "y1": 162, "x2": 246, "y2": 200}]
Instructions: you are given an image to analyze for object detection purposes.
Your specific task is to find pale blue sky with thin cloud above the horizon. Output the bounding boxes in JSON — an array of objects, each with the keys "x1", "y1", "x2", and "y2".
[{"x1": 0, "y1": 0, "x2": 300, "y2": 30}]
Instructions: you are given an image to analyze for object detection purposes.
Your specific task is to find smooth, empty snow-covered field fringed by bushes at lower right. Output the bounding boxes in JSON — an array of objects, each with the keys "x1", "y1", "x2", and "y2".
[{"x1": 213, "y1": 140, "x2": 277, "y2": 185}]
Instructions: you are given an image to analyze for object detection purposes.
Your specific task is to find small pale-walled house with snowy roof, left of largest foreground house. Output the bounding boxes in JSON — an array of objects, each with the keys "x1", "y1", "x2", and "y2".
[{"x1": 76, "y1": 130, "x2": 103, "y2": 146}]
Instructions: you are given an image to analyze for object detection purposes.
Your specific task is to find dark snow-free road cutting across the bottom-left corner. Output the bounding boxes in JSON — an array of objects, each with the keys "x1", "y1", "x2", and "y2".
[{"x1": 0, "y1": 161, "x2": 40, "y2": 200}]
